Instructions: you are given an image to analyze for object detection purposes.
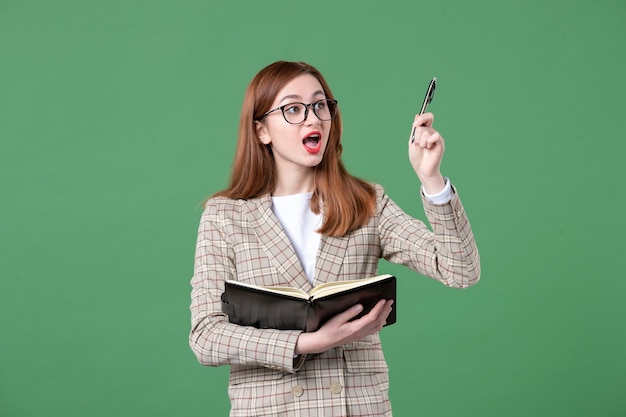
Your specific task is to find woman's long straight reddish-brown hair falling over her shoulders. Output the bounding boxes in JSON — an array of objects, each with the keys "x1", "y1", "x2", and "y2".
[{"x1": 214, "y1": 61, "x2": 376, "y2": 236}]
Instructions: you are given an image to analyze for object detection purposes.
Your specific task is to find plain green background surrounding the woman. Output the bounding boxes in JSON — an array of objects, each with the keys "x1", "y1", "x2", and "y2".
[{"x1": 0, "y1": 0, "x2": 626, "y2": 417}]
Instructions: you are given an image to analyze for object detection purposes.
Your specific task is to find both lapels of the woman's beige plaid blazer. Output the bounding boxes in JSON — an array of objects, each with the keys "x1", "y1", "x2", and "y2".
[{"x1": 245, "y1": 194, "x2": 348, "y2": 291}]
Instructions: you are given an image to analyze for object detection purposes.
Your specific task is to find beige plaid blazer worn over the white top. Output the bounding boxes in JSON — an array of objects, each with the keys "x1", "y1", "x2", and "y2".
[{"x1": 189, "y1": 185, "x2": 480, "y2": 417}]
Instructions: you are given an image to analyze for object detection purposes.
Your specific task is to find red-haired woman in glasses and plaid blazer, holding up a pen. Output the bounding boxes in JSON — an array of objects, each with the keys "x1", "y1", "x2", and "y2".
[{"x1": 190, "y1": 61, "x2": 480, "y2": 416}]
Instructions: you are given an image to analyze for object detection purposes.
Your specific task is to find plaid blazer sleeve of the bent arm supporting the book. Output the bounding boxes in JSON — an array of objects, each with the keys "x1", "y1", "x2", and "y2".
[{"x1": 189, "y1": 201, "x2": 305, "y2": 372}]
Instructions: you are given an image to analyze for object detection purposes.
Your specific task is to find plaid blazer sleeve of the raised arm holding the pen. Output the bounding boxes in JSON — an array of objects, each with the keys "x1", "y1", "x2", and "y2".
[{"x1": 378, "y1": 186, "x2": 480, "y2": 288}]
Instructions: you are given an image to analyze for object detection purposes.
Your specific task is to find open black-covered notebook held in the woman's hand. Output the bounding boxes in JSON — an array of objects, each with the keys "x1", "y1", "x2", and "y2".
[{"x1": 222, "y1": 274, "x2": 396, "y2": 332}]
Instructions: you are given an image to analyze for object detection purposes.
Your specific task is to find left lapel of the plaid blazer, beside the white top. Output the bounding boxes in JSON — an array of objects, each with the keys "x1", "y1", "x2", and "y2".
[{"x1": 245, "y1": 195, "x2": 312, "y2": 291}]
